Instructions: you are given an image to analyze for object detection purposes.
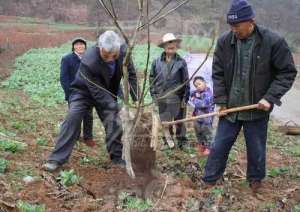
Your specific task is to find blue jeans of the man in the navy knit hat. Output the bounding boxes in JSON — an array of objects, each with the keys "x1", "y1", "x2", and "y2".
[{"x1": 203, "y1": 117, "x2": 269, "y2": 183}]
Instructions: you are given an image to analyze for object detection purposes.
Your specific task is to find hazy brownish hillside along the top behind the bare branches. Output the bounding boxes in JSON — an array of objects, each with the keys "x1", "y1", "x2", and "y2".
[{"x1": 0, "y1": 0, "x2": 300, "y2": 33}]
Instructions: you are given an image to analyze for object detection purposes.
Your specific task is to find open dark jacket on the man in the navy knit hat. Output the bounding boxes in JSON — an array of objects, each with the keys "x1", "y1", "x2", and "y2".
[{"x1": 212, "y1": 26, "x2": 297, "y2": 106}]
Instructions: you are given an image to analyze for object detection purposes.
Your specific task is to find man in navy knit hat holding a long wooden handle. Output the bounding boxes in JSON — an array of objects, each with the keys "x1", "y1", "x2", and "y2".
[{"x1": 203, "y1": 0, "x2": 297, "y2": 192}]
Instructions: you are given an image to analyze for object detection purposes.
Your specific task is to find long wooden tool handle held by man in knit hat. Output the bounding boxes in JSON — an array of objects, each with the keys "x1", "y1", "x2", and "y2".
[{"x1": 162, "y1": 104, "x2": 258, "y2": 125}]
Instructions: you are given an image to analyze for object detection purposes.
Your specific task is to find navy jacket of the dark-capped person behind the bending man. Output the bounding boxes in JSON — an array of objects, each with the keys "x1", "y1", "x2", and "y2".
[{"x1": 60, "y1": 52, "x2": 80, "y2": 101}]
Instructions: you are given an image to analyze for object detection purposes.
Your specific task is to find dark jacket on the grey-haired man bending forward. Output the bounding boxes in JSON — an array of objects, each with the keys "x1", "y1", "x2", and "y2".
[{"x1": 70, "y1": 46, "x2": 137, "y2": 109}]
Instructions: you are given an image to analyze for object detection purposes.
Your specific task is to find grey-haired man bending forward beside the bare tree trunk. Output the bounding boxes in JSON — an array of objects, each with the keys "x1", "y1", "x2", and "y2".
[{"x1": 43, "y1": 31, "x2": 137, "y2": 171}]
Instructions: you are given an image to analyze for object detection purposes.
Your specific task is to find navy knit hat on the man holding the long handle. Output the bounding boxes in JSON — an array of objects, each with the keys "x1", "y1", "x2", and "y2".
[{"x1": 227, "y1": 0, "x2": 255, "y2": 24}]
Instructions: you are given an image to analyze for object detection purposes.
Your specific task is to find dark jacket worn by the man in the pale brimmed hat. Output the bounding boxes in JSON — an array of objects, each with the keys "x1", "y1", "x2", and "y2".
[{"x1": 149, "y1": 53, "x2": 190, "y2": 102}]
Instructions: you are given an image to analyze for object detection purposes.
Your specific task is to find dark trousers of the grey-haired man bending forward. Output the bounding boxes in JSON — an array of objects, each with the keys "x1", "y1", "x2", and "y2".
[{"x1": 48, "y1": 96, "x2": 123, "y2": 164}]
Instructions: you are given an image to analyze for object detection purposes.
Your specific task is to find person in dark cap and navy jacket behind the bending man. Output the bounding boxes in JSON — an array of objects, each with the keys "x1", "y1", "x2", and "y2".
[{"x1": 60, "y1": 38, "x2": 96, "y2": 147}]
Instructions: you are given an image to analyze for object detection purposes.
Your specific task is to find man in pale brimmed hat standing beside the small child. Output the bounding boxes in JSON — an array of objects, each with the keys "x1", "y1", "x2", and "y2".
[{"x1": 149, "y1": 33, "x2": 190, "y2": 148}]
